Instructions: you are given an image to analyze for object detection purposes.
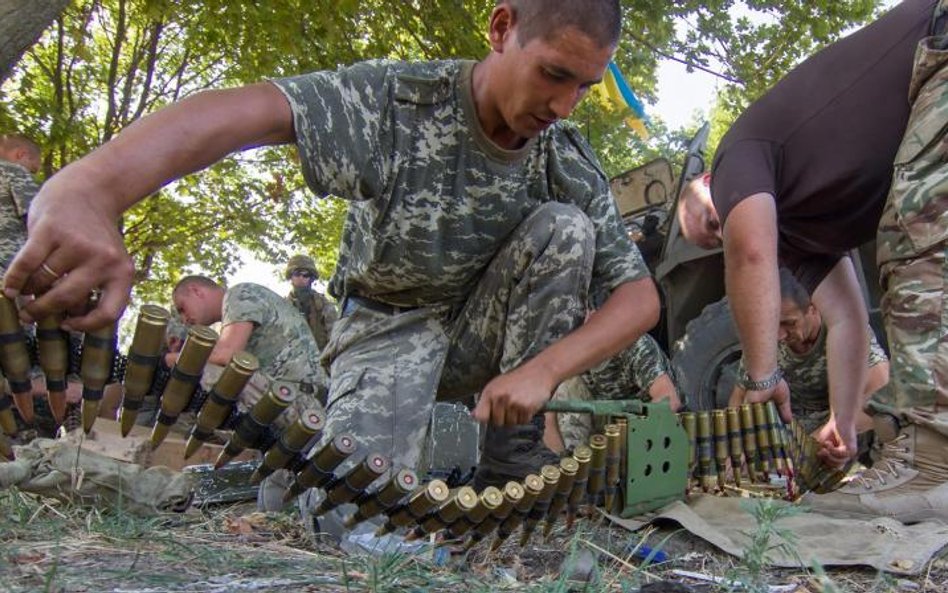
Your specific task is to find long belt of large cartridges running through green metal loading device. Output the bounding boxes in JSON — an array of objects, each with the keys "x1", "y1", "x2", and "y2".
[{"x1": 0, "y1": 296, "x2": 845, "y2": 548}]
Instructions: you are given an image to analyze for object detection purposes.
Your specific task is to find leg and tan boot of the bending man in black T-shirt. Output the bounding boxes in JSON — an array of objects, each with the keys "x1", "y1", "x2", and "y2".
[{"x1": 808, "y1": 31, "x2": 948, "y2": 523}]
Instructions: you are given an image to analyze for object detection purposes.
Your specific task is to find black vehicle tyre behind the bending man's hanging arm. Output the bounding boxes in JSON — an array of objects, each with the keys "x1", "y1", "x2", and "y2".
[{"x1": 672, "y1": 298, "x2": 741, "y2": 410}]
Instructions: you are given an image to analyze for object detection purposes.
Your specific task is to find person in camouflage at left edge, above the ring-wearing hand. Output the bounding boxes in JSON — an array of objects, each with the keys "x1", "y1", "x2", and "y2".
[{"x1": 0, "y1": 135, "x2": 40, "y2": 274}]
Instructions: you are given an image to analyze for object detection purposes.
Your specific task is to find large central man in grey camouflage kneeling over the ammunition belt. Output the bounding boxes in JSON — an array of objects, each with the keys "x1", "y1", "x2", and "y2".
[{"x1": 8, "y1": 0, "x2": 658, "y2": 532}]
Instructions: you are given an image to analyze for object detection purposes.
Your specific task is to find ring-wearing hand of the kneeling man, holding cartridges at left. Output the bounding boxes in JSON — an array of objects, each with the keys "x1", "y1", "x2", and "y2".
[{"x1": 3, "y1": 168, "x2": 134, "y2": 330}]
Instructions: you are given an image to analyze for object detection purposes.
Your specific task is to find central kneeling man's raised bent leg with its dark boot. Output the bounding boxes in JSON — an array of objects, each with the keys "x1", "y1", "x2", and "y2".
[{"x1": 439, "y1": 203, "x2": 595, "y2": 487}]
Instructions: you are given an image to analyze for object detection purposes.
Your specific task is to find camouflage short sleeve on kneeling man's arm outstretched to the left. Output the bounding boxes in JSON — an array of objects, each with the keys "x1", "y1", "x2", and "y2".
[{"x1": 274, "y1": 61, "x2": 394, "y2": 200}]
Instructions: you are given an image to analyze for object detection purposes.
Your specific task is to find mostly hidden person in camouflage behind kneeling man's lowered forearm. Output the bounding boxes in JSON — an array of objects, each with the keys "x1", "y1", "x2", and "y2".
[{"x1": 543, "y1": 334, "x2": 681, "y2": 452}]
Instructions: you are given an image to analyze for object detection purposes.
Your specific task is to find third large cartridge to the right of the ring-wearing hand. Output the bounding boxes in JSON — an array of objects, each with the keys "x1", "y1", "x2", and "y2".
[{"x1": 184, "y1": 351, "x2": 260, "y2": 459}]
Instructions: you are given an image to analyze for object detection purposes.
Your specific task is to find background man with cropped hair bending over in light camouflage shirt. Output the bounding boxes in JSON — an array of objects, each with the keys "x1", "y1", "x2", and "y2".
[{"x1": 172, "y1": 276, "x2": 325, "y2": 425}]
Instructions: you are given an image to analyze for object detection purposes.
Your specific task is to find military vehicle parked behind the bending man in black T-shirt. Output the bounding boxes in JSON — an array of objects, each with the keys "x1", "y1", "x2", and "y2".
[{"x1": 611, "y1": 123, "x2": 885, "y2": 410}]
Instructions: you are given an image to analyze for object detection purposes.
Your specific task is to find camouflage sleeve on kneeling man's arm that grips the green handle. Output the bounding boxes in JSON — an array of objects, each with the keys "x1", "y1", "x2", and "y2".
[{"x1": 554, "y1": 125, "x2": 649, "y2": 294}]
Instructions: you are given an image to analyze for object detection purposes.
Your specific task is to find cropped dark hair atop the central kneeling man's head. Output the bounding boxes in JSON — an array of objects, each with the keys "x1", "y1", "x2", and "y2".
[{"x1": 497, "y1": 0, "x2": 622, "y2": 47}]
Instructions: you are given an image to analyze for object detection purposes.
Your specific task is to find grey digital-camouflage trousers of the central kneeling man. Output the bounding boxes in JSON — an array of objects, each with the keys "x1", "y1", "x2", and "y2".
[{"x1": 324, "y1": 203, "x2": 595, "y2": 476}]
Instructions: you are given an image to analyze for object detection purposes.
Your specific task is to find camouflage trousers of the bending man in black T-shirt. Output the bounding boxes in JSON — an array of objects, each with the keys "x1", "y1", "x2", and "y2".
[{"x1": 876, "y1": 30, "x2": 948, "y2": 407}]
